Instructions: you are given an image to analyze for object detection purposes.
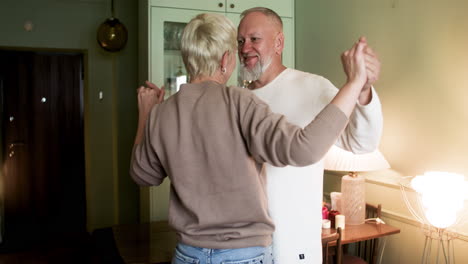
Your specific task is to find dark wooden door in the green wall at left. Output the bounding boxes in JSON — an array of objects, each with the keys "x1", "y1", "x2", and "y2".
[{"x1": 0, "y1": 50, "x2": 86, "y2": 250}]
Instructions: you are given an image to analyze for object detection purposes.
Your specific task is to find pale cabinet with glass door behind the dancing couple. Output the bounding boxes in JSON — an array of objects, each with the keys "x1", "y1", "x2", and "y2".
[{"x1": 138, "y1": 0, "x2": 294, "y2": 222}]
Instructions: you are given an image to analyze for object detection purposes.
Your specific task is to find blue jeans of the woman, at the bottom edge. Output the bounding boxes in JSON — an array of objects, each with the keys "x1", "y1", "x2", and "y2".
[{"x1": 172, "y1": 243, "x2": 274, "y2": 264}]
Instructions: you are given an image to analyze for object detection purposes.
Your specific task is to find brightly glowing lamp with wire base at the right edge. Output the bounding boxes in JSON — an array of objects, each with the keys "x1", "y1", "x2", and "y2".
[{"x1": 400, "y1": 171, "x2": 468, "y2": 264}]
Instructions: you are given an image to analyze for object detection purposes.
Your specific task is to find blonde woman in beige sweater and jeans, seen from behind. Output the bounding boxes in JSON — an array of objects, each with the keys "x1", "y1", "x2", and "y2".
[{"x1": 130, "y1": 14, "x2": 367, "y2": 264}]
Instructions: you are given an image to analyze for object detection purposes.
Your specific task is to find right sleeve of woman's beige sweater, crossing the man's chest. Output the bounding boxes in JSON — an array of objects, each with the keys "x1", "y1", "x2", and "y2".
[{"x1": 240, "y1": 94, "x2": 348, "y2": 167}]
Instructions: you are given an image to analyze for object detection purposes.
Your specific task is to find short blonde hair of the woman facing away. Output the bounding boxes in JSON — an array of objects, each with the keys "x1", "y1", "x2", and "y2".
[{"x1": 181, "y1": 14, "x2": 237, "y2": 78}]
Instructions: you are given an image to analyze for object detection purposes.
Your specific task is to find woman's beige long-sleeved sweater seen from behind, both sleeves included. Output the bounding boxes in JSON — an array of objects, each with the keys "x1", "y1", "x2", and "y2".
[{"x1": 130, "y1": 82, "x2": 348, "y2": 248}]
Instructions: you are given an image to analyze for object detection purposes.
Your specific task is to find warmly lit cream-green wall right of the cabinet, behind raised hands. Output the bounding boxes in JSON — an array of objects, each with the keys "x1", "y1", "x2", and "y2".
[{"x1": 295, "y1": 0, "x2": 468, "y2": 175}]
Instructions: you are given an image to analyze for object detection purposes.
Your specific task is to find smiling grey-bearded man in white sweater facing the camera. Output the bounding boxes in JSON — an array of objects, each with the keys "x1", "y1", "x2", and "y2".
[{"x1": 237, "y1": 8, "x2": 383, "y2": 264}]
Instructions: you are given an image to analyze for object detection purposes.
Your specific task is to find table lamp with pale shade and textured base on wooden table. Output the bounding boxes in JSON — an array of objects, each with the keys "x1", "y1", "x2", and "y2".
[{"x1": 324, "y1": 146, "x2": 390, "y2": 225}]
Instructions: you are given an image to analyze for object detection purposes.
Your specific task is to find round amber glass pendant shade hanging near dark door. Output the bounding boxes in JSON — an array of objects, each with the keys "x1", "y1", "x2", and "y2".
[{"x1": 97, "y1": 17, "x2": 128, "y2": 52}]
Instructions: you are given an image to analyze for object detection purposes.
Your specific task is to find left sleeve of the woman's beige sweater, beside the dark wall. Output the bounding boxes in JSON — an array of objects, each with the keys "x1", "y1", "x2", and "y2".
[{"x1": 130, "y1": 107, "x2": 166, "y2": 186}]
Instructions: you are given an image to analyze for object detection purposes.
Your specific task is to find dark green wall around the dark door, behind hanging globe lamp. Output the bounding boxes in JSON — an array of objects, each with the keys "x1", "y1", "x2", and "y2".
[{"x1": 0, "y1": 0, "x2": 139, "y2": 230}]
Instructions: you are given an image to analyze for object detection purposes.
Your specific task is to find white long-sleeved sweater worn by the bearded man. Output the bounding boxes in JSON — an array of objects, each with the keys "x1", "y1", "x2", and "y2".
[{"x1": 252, "y1": 69, "x2": 383, "y2": 264}]
